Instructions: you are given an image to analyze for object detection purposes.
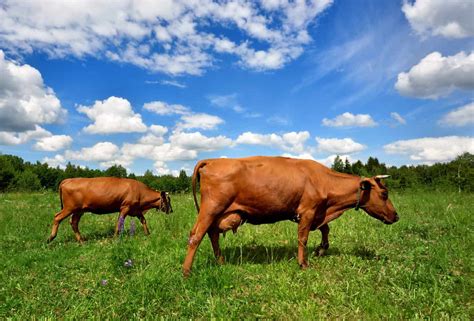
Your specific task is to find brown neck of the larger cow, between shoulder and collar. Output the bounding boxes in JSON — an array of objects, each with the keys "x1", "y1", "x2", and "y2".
[{"x1": 327, "y1": 172, "x2": 360, "y2": 216}]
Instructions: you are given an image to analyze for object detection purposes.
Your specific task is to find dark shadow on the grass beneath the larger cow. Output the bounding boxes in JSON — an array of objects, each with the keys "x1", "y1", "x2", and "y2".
[{"x1": 222, "y1": 244, "x2": 341, "y2": 265}]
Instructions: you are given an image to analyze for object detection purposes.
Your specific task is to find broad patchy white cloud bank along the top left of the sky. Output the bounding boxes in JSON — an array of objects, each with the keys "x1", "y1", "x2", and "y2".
[{"x1": 0, "y1": 0, "x2": 332, "y2": 75}]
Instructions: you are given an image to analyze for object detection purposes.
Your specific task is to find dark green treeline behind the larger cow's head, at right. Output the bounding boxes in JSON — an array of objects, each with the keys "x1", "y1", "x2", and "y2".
[{"x1": 331, "y1": 153, "x2": 474, "y2": 193}]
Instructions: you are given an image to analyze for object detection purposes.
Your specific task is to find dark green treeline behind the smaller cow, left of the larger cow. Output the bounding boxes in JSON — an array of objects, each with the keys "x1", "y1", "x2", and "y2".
[{"x1": 0, "y1": 155, "x2": 191, "y2": 193}]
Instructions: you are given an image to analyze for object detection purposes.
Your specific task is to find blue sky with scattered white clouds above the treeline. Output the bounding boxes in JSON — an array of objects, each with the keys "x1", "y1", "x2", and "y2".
[{"x1": 0, "y1": 0, "x2": 474, "y2": 174}]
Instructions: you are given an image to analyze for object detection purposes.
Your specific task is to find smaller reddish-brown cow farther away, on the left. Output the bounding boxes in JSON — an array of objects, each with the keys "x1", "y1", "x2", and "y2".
[{"x1": 48, "y1": 177, "x2": 173, "y2": 242}]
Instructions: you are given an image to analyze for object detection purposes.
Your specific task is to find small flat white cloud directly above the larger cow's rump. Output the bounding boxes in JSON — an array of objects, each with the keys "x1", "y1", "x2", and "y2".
[{"x1": 170, "y1": 132, "x2": 232, "y2": 151}]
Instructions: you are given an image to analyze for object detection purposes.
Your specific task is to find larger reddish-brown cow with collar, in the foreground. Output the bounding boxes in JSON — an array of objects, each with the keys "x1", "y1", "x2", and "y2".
[{"x1": 183, "y1": 156, "x2": 398, "y2": 276}]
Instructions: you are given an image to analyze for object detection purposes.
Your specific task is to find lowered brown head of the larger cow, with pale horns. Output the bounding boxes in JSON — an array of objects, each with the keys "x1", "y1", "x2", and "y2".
[{"x1": 356, "y1": 175, "x2": 398, "y2": 224}]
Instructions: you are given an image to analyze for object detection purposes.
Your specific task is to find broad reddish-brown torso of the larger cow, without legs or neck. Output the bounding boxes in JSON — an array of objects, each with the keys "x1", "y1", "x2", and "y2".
[{"x1": 200, "y1": 156, "x2": 324, "y2": 219}]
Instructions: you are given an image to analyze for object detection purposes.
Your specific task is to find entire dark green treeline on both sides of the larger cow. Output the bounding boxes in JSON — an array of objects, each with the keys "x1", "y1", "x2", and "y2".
[{"x1": 0, "y1": 153, "x2": 474, "y2": 193}]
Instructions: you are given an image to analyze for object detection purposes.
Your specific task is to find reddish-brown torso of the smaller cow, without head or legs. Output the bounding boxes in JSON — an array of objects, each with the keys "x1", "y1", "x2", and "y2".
[{"x1": 60, "y1": 177, "x2": 141, "y2": 214}]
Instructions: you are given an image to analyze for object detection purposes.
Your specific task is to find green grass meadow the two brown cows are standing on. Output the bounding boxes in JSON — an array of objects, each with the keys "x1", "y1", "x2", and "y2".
[{"x1": 0, "y1": 192, "x2": 474, "y2": 320}]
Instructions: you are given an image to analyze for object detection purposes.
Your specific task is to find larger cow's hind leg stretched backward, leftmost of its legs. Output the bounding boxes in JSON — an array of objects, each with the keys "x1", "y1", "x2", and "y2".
[{"x1": 183, "y1": 206, "x2": 215, "y2": 277}]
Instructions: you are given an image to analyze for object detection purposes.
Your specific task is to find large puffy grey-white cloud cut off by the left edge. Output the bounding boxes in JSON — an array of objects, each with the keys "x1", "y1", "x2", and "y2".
[{"x1": 0, "y1": 49, "x2": 66, "y2": 133}]
